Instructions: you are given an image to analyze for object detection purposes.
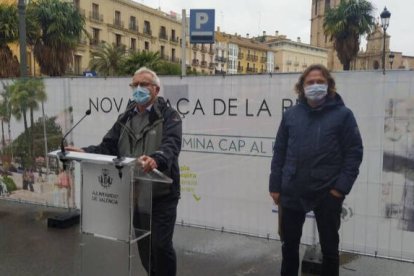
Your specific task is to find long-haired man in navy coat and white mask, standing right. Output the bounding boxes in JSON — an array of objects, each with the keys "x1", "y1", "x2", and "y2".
[{"x1": 269, "y1": 65, "x2": 363, "y2": 276}]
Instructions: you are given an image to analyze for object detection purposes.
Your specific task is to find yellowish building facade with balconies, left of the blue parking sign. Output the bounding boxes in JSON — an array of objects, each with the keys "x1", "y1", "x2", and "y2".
[{"x1": 72, "y1": 0, "x2": 183, "y2": 75}]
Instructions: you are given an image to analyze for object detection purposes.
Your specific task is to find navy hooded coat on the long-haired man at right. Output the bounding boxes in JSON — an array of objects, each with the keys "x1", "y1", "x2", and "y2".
[{"x1": 269, "y1": 94, "x2": 363, "y2": 212}]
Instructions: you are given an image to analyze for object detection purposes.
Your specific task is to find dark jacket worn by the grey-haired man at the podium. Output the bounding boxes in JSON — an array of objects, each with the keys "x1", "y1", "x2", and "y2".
[{"x1": 83, "y1": 97, "x2": 182, "y2": 200}]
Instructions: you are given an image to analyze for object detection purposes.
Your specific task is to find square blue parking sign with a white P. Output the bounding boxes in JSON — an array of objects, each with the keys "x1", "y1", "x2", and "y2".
[{"x1": 190, "y1": 9, "x2": 215, "y2": 43}]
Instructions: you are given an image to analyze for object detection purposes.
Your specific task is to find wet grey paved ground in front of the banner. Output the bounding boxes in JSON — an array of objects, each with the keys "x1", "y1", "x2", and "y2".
[{"x1": 0, "y1": 200, "x2": 414, "y2": 276}]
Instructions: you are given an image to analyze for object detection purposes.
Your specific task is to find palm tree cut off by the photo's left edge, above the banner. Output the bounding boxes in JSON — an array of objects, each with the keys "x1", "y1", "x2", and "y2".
[{"x1": 0, "y1": 3, "x2": 20, "y2": 78}]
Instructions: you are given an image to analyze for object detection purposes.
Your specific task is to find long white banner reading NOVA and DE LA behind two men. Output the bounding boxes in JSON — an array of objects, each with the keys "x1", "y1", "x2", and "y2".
[{"x1": 2, "y1": 71, "x2": 414, "y2": 261}]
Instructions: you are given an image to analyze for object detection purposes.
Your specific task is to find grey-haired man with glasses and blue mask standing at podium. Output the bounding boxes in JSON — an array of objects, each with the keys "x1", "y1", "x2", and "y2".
[{"x1": 66, "y1": 67, "x2": 182, "y2": 276}]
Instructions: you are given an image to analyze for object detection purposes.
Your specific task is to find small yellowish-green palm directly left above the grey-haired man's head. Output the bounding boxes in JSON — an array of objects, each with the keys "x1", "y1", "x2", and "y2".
[{"x1": 89, "y1": 42, "x2": 126, "y2": 77}]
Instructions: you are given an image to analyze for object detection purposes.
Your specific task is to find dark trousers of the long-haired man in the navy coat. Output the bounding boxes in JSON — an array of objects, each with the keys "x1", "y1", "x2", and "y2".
[{"x1": 281, "y1": 194, "x2": 343, "y2": 276}]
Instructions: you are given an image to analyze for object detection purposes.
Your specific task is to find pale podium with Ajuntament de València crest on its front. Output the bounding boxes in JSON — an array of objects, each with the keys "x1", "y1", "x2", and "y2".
[{"x1": 48, "y1": 150, "x2": 172, "y2": 276}]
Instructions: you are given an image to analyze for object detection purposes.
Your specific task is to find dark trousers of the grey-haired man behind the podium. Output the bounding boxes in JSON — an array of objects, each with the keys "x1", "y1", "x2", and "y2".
[{"x1": 134, "y1": 200, "x2": 178, "y2": 276}]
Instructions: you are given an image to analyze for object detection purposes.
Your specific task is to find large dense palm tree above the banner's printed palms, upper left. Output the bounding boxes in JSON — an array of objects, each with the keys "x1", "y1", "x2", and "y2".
[{"x1": 27, "y1": 0, "x2": 85, "y2": 76}]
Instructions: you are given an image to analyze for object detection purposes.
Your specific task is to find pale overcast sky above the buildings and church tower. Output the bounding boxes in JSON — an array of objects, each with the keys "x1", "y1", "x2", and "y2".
[{"x1": 134, "y1": 0, "x2": 414, "y2": 56}]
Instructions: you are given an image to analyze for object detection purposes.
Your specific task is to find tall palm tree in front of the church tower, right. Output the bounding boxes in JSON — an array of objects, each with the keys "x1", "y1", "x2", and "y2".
[{"x1": 323, "y1": 0, "x2": 375, "y2": 70}]
